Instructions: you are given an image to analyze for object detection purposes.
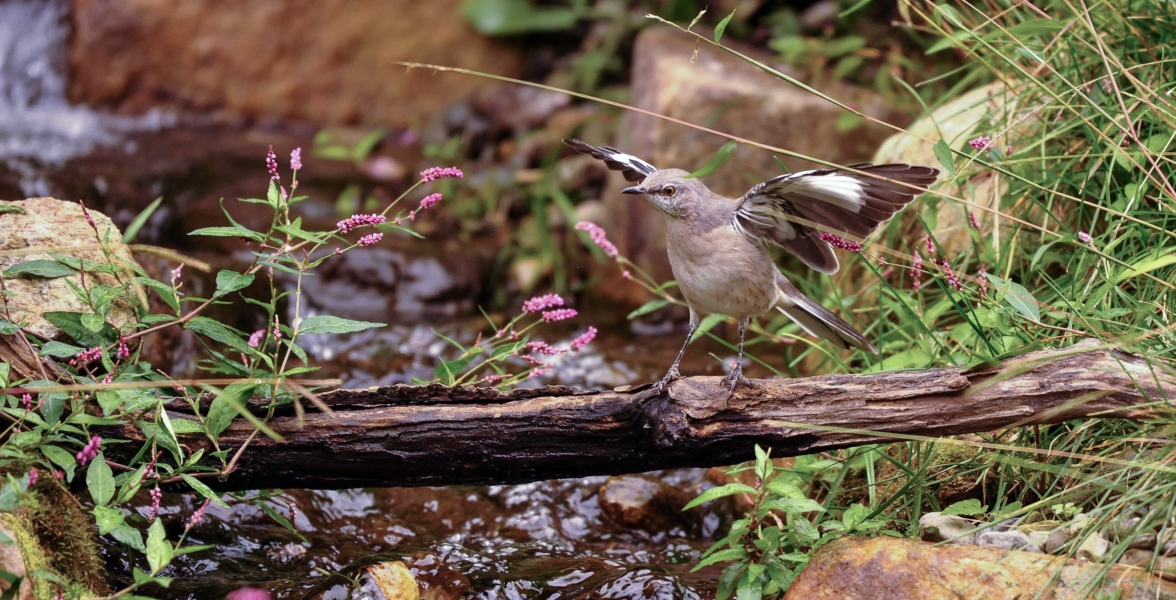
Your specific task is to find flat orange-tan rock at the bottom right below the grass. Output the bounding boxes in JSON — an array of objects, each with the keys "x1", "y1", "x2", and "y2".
[{"x1": 784, "y1": 536, "x2": 1176, "y2": 600}]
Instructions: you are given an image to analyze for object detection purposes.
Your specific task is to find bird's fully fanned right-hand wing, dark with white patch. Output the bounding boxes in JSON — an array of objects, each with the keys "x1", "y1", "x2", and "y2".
[{"x1": 731, "y1": 164, "x2": 940, "y2": 274}]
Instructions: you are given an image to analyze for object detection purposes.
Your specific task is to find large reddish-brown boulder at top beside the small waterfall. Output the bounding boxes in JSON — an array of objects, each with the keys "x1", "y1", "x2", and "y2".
[{"x1": 69, "y1": 0, "x2": 521, "y2": 126}]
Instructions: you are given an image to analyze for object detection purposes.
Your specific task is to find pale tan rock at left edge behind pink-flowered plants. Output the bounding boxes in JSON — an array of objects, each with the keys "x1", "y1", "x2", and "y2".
[{"x1": 0, "y1": 198, "x2": 146, "y2": 379}]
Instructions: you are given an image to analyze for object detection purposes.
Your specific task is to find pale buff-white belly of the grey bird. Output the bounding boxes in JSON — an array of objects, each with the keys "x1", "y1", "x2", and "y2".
[{"x1": 668, "y1": 227, "x2": 777, "y2": 319}]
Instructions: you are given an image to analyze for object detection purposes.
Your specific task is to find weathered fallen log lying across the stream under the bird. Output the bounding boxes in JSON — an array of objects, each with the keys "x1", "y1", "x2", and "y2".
[{"x1": 112, "y1": 345, "x2": 1176, "y2": 491}]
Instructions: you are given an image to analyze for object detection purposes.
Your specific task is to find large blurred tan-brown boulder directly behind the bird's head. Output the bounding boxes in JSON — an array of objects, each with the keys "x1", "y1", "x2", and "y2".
[{"x1": 589, "y1": 27, "x2": 903, "y2": 279}]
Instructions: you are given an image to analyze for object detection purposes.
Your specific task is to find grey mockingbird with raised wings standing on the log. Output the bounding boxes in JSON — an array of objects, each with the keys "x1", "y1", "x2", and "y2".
[{"x1": 563, "y1": 140, "x2": 938, "y2": 392}]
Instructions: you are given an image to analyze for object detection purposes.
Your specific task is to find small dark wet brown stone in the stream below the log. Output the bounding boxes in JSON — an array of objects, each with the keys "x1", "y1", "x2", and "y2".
[{"x1": 597, "y1": 475, "x2": 702, "y2": 535}]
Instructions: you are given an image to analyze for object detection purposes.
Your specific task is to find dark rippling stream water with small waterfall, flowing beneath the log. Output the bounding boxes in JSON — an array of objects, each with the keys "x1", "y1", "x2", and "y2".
[{"x1": 0, "y1": 0, "x2": 771, "y2": 600}]
